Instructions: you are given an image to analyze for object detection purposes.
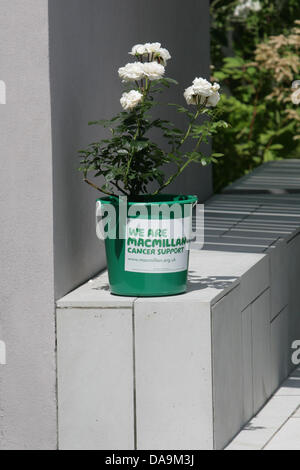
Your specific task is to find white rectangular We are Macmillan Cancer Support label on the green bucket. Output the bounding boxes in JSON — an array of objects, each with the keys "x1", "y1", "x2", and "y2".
[{"x1": 125, "y1": 217, "x2": 190, "y2": 273}]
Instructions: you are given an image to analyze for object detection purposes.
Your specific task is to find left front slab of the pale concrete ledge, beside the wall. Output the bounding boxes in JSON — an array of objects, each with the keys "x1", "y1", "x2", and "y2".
[{"x1": 58, "y1": 307, "x2": 134, "y2": 450}]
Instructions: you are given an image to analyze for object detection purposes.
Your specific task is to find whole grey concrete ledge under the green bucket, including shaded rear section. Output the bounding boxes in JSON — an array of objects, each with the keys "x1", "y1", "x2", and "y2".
[{"x1": 57, "y1": 162, "x2": 300, "y2": 450}]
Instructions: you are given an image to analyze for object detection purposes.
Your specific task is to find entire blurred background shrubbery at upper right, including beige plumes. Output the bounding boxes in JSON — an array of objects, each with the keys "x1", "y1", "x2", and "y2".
[{"x1": 211, "y1": 0, "x2": 300, "y2": 192}]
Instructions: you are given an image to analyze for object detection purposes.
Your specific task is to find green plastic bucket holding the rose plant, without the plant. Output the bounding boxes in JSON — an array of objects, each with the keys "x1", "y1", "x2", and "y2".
[{"x1": 97, "y1": 195, "x2": 197, "y2": 297}]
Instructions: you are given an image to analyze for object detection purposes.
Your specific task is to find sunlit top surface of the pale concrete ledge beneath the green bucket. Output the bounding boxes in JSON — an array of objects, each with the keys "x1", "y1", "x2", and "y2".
[{"x1": 57, "y1": 250, "x2": 265, "y2": 309}]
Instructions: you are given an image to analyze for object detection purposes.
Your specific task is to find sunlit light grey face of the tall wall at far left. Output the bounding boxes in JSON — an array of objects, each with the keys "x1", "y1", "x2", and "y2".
[{"x1": 0, "y1": 0, "x2": 56, "y2": 450}]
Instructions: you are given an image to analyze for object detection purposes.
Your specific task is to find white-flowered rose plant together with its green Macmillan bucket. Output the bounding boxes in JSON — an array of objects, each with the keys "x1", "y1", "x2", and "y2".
[{"x1": 80, "y1": 43, "x2": 227, "y2": 296}]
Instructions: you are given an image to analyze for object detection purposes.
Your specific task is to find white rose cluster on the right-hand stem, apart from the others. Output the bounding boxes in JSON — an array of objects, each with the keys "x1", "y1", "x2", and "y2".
[{"x1": 184, "y1": 78, "x2": 221, "y2": 107}]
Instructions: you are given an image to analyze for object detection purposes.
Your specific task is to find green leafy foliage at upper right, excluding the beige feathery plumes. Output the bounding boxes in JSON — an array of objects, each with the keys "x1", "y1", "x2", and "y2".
[{"x1": 210, "y1": 0, "x2": 300, "y2": 192}]
